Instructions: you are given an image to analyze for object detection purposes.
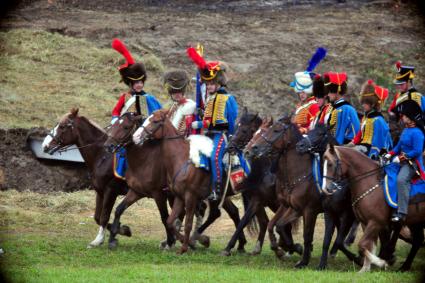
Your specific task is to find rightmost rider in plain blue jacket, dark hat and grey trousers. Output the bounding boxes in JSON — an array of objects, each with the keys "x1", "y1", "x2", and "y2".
[{"x1": 385, "y1": 100, "x2": 425, "y2": 222}]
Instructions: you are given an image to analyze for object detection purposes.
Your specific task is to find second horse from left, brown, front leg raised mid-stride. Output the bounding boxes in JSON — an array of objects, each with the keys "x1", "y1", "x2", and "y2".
[{"x1": 104, "y1": 112, "x2": 180, "y2": 249}]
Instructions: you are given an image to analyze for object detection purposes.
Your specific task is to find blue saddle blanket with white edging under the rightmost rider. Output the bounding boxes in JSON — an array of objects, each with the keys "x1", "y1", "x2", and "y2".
[{"x1": 383, "y1": 163, "x2": 425, "y2": 208}]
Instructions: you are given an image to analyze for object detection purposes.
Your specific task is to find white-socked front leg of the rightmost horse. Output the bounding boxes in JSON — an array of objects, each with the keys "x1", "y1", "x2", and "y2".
[{"x1": 359, "y1": 221, "x2": 387, "y2": 272}]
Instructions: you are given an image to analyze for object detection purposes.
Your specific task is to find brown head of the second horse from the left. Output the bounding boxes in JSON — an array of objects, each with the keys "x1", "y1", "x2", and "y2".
[{"x1": 104, "y1": 112, "x2": 143, "y2": 152}]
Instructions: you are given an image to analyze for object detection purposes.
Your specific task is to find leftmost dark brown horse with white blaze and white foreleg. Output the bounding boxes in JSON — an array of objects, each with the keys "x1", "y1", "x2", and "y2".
[{"x1": 43, "y1": 108, "x2": 131, "y2": 248}]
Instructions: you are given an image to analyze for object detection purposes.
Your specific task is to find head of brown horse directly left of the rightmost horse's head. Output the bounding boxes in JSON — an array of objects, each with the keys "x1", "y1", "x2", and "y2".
[{"x1": 247, "y1": 116, "x2": 301, "y2": 160}]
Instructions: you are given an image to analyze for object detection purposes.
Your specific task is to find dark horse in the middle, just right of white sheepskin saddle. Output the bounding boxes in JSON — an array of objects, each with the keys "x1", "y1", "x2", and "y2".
[{"x1": 222, "y1": 110, "x2": 302, "y2": 256}]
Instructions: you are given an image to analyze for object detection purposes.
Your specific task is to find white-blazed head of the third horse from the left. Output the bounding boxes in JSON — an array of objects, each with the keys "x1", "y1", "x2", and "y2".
[{"x1": 133, "y1": 109, "x2": 169, "y2": 144}]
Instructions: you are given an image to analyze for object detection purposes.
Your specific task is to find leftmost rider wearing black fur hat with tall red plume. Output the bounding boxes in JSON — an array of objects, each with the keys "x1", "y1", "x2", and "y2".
[{"x1": 111, "y1": 39, "x2": 162, "y2": 179}]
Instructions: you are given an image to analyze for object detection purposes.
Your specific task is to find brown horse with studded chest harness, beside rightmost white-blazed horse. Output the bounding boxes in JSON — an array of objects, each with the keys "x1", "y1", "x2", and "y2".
[{"x1": 246, "y1": 117, "x2": 323, "y2": 268}]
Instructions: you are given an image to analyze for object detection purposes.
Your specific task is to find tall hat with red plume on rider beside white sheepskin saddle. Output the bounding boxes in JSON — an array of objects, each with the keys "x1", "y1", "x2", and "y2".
[{"x1": 187, "y1": 47, "x2": 227, "y2": 86}]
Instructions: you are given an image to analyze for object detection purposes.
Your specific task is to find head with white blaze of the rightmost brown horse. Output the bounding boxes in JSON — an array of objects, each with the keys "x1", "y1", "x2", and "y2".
[{"x1": 322, "y1": 144, "x2": 350, "y2": 195}]
